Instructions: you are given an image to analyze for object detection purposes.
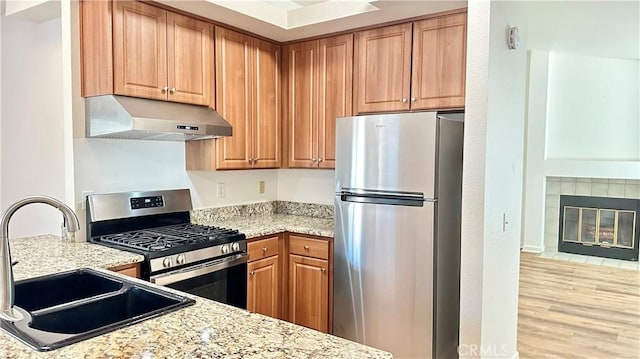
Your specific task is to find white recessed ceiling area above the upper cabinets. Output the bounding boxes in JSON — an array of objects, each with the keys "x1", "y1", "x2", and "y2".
[{"x1": 156, "y1": 0, "x2": 467, "y2": 42}]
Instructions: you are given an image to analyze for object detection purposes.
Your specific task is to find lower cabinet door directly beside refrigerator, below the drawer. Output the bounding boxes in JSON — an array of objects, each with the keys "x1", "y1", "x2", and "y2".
[{"x1": 289, "y1": 254, "x2": 329, "y2": 333}]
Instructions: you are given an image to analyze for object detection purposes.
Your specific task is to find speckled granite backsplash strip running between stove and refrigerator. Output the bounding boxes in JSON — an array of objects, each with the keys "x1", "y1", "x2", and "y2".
[{"x1": 191, "y1": 201, "x2": 333, "y2": 223}]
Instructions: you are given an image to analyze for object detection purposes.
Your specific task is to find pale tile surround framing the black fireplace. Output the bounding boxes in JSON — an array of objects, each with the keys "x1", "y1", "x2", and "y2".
[{"x1": 544, "y1": 177, "x2": 640, "y2": 253}]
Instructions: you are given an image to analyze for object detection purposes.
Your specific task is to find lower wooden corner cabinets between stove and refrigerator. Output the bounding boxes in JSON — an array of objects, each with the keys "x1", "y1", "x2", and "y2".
[{"x1": 247, "y1": 233, "x2": 333, "y2": 333}]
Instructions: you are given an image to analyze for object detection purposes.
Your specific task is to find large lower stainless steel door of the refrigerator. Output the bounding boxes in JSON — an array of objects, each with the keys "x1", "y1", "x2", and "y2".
[{"x1": 333, "y1": 195, "x2": 435, "y2": 358}]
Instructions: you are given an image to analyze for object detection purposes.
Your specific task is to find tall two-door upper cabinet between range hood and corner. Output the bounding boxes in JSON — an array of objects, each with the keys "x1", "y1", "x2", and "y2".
[{"x1": 215, "y1": 27, "x2": 280, "y2": 169}]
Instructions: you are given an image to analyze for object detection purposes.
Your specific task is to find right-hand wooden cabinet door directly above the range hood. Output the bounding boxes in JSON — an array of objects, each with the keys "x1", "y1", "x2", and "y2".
[{"x1": 167, "y1": 12, "x2": 213, "y2": 107}]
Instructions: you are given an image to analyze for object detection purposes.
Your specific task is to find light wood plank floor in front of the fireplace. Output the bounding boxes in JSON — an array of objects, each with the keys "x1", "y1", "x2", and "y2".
[{"x1": 518, "y1": 253, "x2": 640, "y2": 359}]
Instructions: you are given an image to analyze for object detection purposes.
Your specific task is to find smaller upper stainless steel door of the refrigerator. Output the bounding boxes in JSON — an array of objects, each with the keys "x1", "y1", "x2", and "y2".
[{"x1": 335, "y1": 112, "x2": 437, "y2": 198}]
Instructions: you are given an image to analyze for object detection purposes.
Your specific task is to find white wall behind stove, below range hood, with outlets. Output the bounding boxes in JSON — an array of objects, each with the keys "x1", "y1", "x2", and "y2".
[{"x1": 73, "y1": 138, "x2": 278, "y2": 240}]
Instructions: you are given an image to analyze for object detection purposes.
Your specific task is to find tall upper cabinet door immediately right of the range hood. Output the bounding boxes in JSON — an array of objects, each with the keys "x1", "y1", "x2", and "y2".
[{"x1": 215, "y1": 27, "x2": 253, "y2": 169}]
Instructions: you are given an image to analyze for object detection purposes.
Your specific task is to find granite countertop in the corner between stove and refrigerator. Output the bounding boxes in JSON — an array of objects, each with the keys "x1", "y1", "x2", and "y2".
[{"x1": 200, "y1": 214, "x2": 333, "y2": 239}]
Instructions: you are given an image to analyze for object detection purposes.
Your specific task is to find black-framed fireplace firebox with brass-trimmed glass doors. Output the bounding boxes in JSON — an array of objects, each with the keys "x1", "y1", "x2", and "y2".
[{"x1": 558, "y1": 196, "x2": 640, "y2": 261}]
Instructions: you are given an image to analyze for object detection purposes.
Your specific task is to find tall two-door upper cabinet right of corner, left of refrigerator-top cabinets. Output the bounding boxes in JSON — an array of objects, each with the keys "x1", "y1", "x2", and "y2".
[{"x1": 285, "y1": 34, "x2": 353, "y2": 168}]
